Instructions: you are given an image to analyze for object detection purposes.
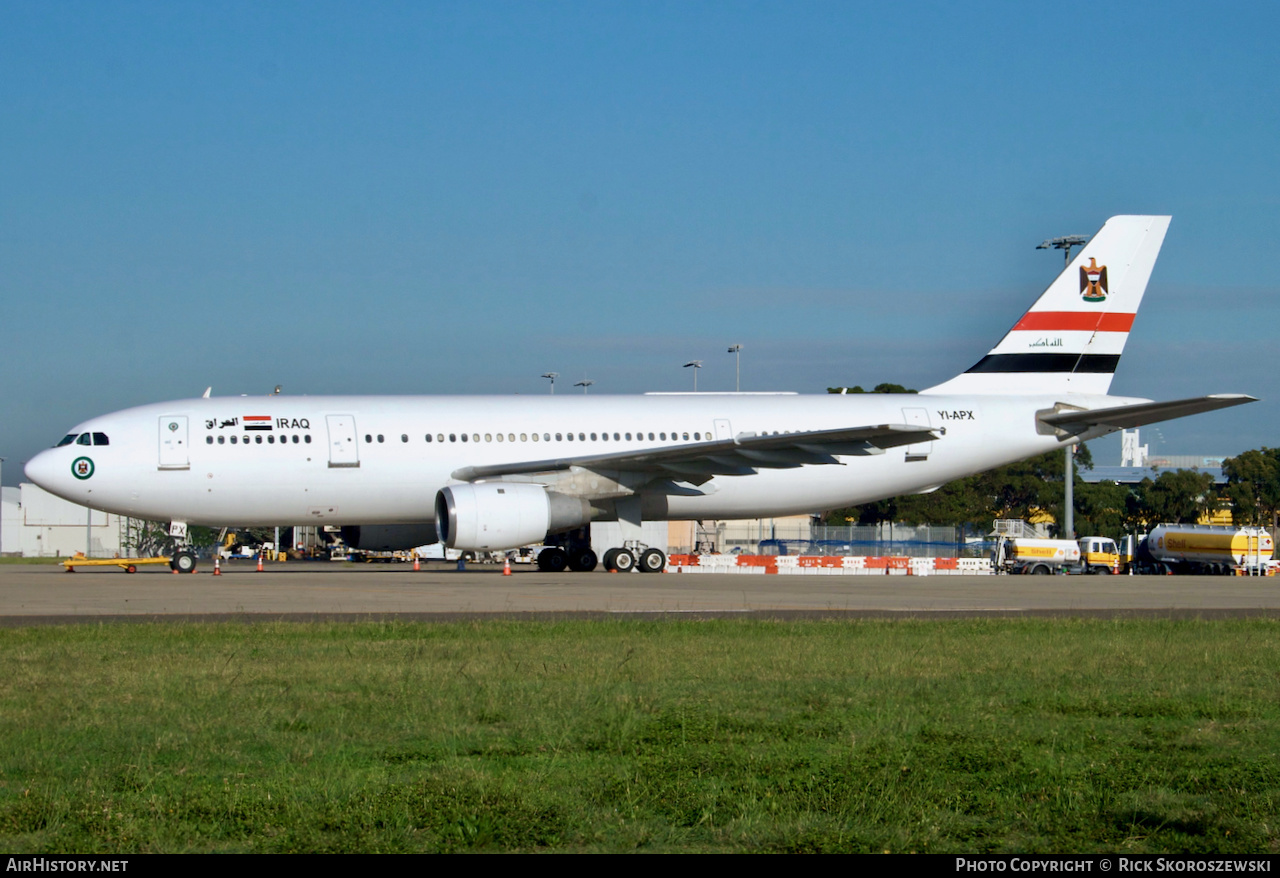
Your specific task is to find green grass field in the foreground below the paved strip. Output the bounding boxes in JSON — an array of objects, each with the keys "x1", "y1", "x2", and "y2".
[{"x1": 0, "y1": 619, "x2": 1280, "y2": 854}]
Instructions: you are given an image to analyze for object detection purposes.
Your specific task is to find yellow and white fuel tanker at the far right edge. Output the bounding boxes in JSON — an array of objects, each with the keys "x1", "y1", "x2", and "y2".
[{"x1": 1121, "y1": 525, "x2": 1275, "y2": 576}]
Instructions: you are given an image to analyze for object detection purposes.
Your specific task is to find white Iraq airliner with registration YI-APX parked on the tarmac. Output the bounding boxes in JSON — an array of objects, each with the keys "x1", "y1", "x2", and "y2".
[{"x1": 26, "y1": 216, "x2": 1253, "y2": 571}]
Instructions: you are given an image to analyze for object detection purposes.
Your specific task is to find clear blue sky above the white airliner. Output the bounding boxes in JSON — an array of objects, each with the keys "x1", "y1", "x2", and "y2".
[{"x1": 0, "y1": 3, "x2": 1280, "y2": 484}]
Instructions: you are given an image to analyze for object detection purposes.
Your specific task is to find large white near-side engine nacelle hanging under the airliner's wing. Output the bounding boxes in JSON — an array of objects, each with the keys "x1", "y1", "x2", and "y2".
[{"x1": 435, "y1": 481, "x2": 591, "y2": 550}]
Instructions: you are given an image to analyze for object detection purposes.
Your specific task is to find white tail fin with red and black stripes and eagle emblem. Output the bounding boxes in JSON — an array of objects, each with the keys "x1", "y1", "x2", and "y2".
[{"x1": 922, "y1": 216, "x2": 1170, "y2": 394}]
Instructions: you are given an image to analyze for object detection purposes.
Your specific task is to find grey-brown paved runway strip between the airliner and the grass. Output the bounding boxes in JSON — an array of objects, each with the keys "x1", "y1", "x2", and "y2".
[{"x1": 0, "y1": 562, "x2": 1280, "y2": 626}]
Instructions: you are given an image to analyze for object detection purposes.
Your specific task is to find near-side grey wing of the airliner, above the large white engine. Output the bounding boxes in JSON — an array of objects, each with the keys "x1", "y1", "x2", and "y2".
[{"x1": 453, "y1": 424, "x2": 940, "y2": 481}]
